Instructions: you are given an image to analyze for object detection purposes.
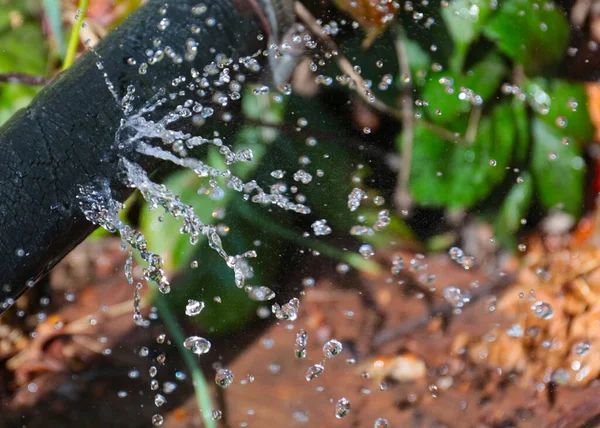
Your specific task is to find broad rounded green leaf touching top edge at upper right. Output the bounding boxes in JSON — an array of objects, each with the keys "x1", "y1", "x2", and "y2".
[{"x1": 483, "y1": 0, "x2": 569, "y2": 74}]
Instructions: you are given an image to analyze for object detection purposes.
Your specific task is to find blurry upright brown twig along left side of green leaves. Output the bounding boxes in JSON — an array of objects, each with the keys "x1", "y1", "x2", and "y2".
[{"x1": 394, "y1": 25, "x2": 415, "y2": 210}]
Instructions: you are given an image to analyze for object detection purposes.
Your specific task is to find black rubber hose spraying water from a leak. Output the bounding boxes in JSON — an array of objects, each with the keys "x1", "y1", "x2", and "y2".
[{"x1": 0, "y1": 0, "x2": 282, "y2": 311}]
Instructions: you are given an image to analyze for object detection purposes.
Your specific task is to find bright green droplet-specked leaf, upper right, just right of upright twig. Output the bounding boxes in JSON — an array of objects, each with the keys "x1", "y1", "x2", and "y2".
[{"x1": 423, "y1": 53, "x2": 506, "y2": 125}]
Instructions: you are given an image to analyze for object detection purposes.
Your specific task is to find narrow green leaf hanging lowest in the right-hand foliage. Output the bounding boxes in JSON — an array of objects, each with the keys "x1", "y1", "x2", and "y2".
[{"x1": 494, "y1": 172, "x2": 533, "y2": 248}]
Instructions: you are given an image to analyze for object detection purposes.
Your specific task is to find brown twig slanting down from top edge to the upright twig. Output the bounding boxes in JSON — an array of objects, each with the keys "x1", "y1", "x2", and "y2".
[{"x1": 294, "y1": 2, "x2": 402, "y2": 120}]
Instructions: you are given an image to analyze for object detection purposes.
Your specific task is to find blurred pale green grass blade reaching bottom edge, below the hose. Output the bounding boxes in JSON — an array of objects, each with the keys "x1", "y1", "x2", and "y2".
[{"x1": 153, "y1": 292, "x2": 217, "y2": 428}]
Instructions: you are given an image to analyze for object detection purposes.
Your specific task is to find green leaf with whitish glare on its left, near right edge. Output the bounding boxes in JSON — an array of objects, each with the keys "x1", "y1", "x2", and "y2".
[{"x1": 525, "y1": 79, "x2": 594, "y2": 142}]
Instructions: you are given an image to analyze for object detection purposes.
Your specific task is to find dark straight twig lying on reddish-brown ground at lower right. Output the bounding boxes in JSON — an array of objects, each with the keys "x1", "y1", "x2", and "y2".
[{"x1": 372, "y1": 273, "x2": 517, "y2": 348}]
